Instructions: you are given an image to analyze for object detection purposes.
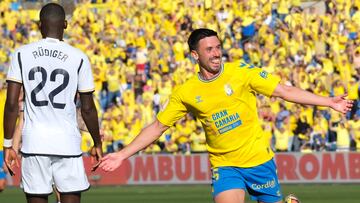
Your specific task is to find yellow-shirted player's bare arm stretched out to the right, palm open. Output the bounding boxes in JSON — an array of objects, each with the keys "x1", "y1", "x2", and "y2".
[{"x1": 272, "y1": 84, "x2": 353, "y2": 113}]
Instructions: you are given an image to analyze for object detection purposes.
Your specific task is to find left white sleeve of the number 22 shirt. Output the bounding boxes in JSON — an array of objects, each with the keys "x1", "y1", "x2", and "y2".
[{"x1": 6, "y1": 51, "x2": 22, "y2": 83}]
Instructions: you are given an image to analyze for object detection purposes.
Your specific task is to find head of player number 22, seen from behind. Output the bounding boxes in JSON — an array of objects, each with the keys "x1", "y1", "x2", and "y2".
[{"x1": 40, "y1": 3, "x2": 67, "y2": 40}]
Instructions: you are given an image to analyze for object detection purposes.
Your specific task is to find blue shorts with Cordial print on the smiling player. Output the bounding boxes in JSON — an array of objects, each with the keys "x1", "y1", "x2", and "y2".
[{"x1": 211, "y1": 159, "x2": 282, "y2": 202}]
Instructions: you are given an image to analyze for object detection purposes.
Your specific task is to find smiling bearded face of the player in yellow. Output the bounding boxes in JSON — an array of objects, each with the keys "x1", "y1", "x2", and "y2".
[{"x1": 192, "y1": 36, "x2": 222, "y2": 75}]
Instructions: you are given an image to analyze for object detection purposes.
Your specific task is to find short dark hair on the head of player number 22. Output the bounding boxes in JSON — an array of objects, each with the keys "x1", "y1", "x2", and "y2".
[{"x1": 40, "y1": 3, "x2": 65, "y2": 22}]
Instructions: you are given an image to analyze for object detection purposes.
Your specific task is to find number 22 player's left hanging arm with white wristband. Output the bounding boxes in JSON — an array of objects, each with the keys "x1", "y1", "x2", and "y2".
[{"x1": 4, "y1": 82, "x2": 22, "y2": 175}]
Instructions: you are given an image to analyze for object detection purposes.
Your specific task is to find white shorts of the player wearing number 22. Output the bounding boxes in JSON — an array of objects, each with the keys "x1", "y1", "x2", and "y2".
[{"x1": 21, "y1": 155, "x2": 90, "y2": 195}]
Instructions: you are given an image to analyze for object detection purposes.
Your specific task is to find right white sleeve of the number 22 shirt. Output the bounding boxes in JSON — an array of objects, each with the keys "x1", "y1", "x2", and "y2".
[{"x1": 78, "y1": 57, "x2": 94, "y2": 93}]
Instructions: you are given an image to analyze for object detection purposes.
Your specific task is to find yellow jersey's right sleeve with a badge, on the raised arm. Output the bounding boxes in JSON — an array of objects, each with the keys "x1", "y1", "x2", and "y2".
[{"x1": 249, "y1": 68, "x2": 280, "y2": 97}]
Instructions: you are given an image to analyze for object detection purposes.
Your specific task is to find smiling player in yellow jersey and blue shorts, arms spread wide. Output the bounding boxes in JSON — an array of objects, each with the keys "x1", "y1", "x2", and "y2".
[{"x1": 100, "y1": 28, "x2": 352, "y2": 203}]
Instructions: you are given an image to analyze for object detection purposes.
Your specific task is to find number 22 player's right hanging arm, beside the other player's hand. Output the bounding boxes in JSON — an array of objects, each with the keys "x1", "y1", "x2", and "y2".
[{"x1": 80, "y1": 93, "x2": 103, "y2": 171}]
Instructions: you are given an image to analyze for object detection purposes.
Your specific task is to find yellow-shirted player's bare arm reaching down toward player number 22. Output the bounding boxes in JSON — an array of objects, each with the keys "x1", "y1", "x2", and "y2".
[{"x1": 100, "y1": 119, "x2": 169, "y2": 171}]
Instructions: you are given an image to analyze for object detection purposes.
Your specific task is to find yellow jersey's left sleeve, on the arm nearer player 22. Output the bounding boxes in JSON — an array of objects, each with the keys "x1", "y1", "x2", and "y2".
[{"x1": 157, "y1": 92, "x2": 187, "y2": 126}]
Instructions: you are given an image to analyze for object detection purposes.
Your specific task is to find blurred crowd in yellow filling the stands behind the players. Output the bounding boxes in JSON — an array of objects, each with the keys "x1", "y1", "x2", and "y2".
[{"x1": 0, "y1": 0, "x2": 360, "y2": 154}]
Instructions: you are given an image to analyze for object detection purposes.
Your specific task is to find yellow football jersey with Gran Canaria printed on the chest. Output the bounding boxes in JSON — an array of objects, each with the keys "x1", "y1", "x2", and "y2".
[{"x1": 157, "y1": 61, "x2": 280, "y2": 167}]
